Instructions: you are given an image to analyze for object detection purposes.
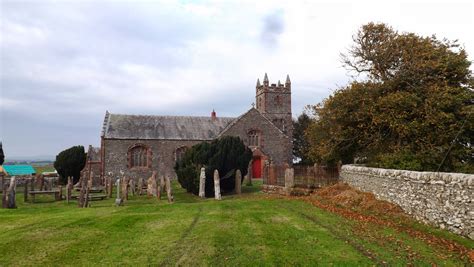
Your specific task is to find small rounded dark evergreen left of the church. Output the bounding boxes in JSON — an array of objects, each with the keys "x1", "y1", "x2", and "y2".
[{"x1": 54, "y1": 146, "x2": 86, "y2": 184}]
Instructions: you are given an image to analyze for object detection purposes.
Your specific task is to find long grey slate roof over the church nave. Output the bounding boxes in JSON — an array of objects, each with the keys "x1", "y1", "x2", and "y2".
[{"x1": 102, "y1": 112, "x2": 235, "y2": 140}]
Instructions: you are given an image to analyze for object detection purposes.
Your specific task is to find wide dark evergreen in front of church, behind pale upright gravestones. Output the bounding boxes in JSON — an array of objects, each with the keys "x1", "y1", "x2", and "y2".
[{"x1": 174, "y1": 136, "x2": 252, "y2": 197}]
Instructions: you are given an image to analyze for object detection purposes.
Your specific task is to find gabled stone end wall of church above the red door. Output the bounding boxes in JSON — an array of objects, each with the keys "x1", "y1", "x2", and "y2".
[{"x1": 219, "y1": 109, "x2": 292, "y2": 164}]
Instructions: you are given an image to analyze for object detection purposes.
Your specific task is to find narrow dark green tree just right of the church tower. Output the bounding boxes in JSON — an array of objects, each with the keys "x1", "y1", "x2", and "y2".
[{"x1": 293, "y1": 112, "x2": 313, "y2": 165}]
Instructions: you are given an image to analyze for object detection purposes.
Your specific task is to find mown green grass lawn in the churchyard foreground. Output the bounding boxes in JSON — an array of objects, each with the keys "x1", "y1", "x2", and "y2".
[{"x1": 0, "y1": 182, "x2": 474, "y2": 266}]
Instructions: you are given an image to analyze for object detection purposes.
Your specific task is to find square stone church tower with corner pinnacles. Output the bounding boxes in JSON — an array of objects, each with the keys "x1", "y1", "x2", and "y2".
[{"x1": 256, "y1": 73, "x2": 293, "y2": 138}]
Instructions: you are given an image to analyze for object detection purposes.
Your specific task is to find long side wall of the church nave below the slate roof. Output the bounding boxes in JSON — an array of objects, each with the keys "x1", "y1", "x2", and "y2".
[{"x1": 103, "y1": 139, "x2": 201, "y2": 179}]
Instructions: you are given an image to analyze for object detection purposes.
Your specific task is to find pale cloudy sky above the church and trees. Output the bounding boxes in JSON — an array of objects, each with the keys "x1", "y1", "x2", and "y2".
[{"x1": 0, "y1": 0, "x2": 474, "y2": 160}]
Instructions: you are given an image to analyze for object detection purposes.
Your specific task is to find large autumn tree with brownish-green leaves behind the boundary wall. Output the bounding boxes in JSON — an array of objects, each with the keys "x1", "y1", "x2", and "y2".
[{"x1": 307, "y1": 23, "x2": 474, "y2": 172}]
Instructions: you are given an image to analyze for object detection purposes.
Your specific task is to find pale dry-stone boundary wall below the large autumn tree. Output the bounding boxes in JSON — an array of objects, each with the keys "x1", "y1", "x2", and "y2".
[{"x1": 340, "y1": 165, "x2": 474, "y2": 239}]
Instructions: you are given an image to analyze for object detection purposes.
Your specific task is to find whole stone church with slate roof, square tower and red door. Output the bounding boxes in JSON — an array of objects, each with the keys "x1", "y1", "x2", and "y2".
[{"x1": 99, "y1": 74, "x2": 293, "y2": 179}]
